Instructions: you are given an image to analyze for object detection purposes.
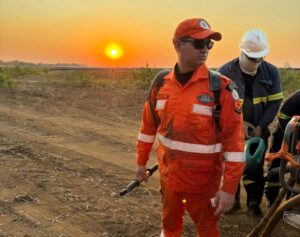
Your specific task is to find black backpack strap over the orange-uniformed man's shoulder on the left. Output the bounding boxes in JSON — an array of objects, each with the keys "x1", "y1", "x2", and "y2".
[{"x1": 147, "y1": 69, "x2": 170, "y2": 129}]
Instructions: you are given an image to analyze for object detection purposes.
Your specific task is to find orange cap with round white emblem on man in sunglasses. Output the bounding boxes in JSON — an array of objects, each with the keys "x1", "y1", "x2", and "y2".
[{"x1": 173, "y1": 18, "x2": 222, "y2": 41}]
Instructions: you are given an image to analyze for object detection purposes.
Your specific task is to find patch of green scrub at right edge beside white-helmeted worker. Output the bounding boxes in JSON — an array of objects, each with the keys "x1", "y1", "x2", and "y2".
[{"x1": 279, "y1": 68, "x2": 300, "y2": 98}]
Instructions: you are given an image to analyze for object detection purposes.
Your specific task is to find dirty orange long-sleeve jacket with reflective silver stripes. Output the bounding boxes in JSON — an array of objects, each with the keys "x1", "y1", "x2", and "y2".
[{"x1": 136, "y1": 65, "x2": 245, "y2": 194}]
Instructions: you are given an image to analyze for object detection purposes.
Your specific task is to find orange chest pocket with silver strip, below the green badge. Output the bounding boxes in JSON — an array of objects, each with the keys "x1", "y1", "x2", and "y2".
[{"x1": 188, "y1": 104, "x2": 215, "y2": 137}]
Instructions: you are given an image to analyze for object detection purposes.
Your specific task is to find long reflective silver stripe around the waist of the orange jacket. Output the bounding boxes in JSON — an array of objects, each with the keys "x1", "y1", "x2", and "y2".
[{"x1": 158, "y1": 134, "x2": 221, "y2": 154}]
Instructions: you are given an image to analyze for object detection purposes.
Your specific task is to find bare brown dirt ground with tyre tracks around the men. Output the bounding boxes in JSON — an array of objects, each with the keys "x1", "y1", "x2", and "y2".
[{"x1": 0, "y1": 71, "x2": 299, "y2": 237}]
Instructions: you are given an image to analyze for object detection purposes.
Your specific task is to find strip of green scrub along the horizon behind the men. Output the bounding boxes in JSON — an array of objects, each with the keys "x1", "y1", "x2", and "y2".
[{"x1": 0, "y1": 65, "x2": 300, "y2": 95}]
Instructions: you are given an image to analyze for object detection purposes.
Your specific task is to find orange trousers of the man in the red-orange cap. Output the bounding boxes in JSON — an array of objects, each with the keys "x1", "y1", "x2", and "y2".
[{"x1": 161, "y1": 188, "x2": 220, "y2": 237}]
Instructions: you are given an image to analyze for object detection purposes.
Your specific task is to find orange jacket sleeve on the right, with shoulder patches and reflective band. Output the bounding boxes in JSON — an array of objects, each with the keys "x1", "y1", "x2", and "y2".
[{"x1": 220, "y1": 77, "x2": 245, "y2": 194}]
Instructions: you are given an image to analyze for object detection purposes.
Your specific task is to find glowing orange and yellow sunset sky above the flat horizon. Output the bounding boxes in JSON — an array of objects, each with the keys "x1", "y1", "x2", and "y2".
[{"x1": 0, "y1": 0, "x2": 300, "y2": 67}]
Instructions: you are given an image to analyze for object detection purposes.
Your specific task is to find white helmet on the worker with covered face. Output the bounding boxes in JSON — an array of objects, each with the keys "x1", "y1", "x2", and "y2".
[{"x1": 240, "y1": 29, "x2": 269, "y2": 58}]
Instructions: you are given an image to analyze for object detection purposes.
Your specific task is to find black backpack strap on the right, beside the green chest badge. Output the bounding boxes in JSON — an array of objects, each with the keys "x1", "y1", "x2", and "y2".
[{"x1": 209, "y1": 70, "x2": 222, "y2": 125}]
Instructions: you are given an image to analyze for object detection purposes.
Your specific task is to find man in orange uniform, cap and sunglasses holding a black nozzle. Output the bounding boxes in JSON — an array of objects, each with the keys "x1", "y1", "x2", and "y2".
[{"x1": 136, "y1": 19, "x2": 245, "y2": 237}]
